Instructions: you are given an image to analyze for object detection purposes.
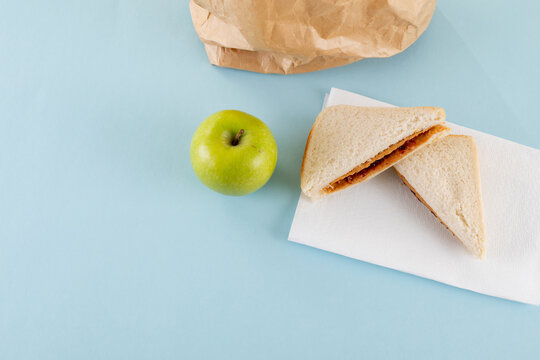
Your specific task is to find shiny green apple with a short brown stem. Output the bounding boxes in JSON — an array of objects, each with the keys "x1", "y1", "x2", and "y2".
[{"x1": 190, "y1": 110, "x2": 277, "y2": 196}]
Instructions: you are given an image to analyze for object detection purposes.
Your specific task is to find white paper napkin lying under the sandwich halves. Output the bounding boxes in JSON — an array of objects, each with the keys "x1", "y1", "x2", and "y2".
[{"x1": 289, "y1": 88, "x2": 540, "y2": 305}]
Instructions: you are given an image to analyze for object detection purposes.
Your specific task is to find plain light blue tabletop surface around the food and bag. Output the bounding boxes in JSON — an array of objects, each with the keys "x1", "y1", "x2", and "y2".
[{"x1": 0, "y1": 0, "x2": 540, "y2": 359}]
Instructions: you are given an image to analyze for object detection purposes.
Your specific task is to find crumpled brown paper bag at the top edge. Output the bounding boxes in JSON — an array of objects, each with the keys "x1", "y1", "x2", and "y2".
[{"x1": 190, "y1": 0, "x2": 436, "y2": 74}]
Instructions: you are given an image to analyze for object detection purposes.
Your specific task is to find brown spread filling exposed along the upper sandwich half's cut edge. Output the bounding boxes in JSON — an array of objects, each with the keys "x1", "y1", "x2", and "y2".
[{"x1": 322, "y1": 125, "x2": 449, "y2": 194}]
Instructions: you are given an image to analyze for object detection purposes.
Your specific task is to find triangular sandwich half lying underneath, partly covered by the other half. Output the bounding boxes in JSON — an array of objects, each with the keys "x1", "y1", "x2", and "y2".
[{"x1": 394, "y1": 135, "x2": 486, "y2": 258}]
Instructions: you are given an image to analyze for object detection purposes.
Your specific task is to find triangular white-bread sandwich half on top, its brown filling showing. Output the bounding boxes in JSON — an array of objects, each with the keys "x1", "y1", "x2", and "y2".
[{"x1": 301, "y1": 105, "x2": 449, "y2": 200}]
